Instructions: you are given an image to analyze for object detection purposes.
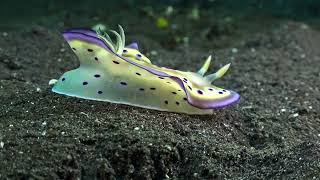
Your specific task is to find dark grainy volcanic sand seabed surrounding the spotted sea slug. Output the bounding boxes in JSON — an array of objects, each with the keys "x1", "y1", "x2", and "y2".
[{"x1": 0, "y1": 6, "x2": 320, "y2": 179}]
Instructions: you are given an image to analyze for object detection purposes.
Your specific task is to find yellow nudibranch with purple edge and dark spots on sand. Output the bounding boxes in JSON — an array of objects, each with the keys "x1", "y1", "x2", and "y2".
[{"x1": 49, "y1": 26, "x2": 240, "y2": 114}]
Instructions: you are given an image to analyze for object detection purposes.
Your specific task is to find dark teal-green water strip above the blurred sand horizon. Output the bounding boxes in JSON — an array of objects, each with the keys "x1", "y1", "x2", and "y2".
[{"x1": 0, "y1": 0, "x2": 320, "y2": 24}]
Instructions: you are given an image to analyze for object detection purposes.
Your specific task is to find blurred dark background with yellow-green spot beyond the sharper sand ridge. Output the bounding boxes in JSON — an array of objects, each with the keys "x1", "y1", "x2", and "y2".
[{"x1": 0, "y1": 0, "x2": 320, "y2": 49}]
